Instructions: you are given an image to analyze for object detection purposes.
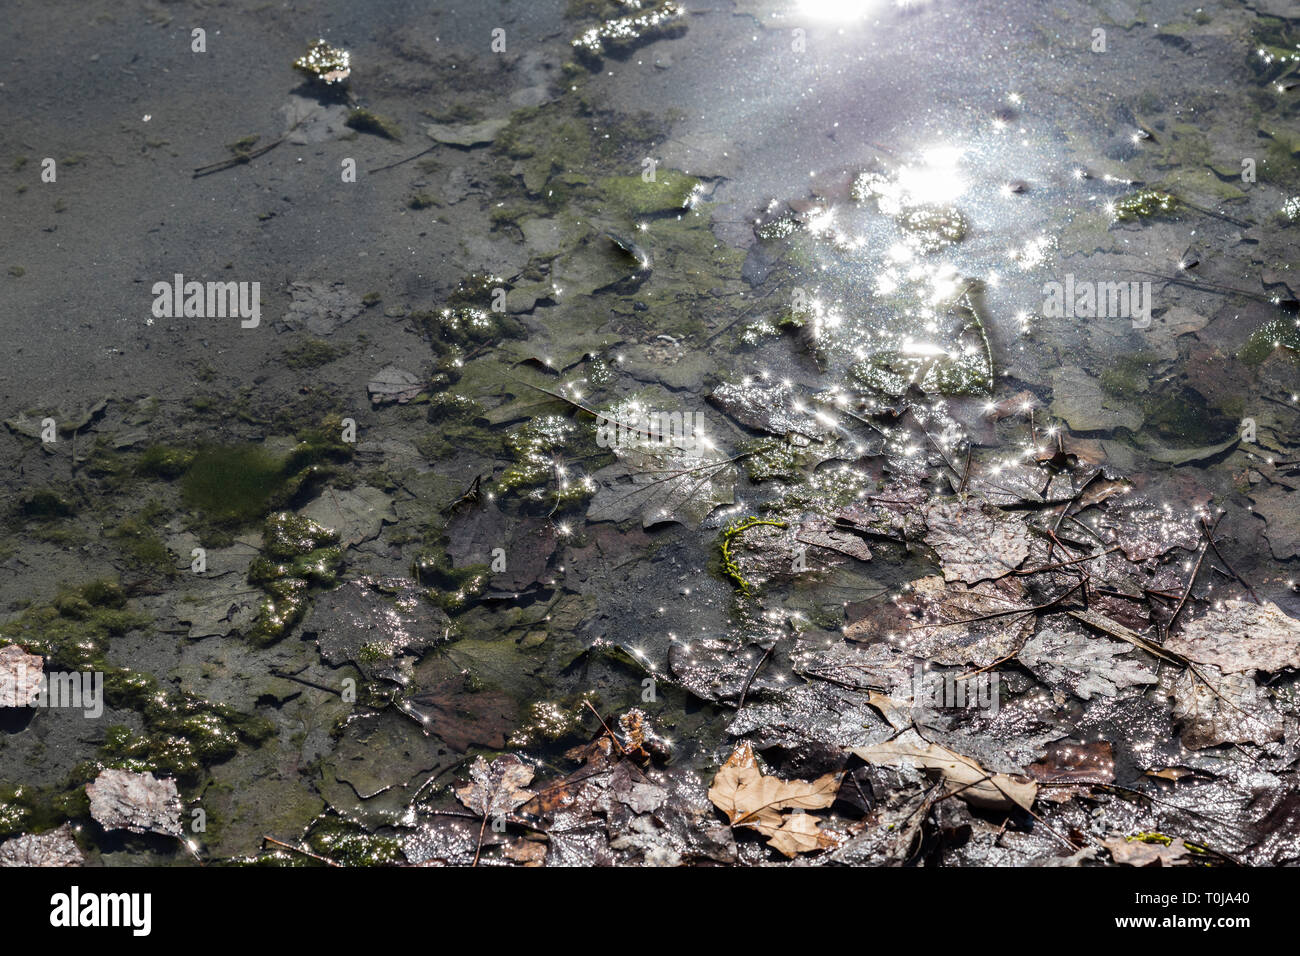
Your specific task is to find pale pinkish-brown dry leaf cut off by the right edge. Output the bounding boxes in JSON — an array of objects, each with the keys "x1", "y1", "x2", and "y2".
[{"x1": 1165, "y1": 601, "x2": 1300, "y2": 675}]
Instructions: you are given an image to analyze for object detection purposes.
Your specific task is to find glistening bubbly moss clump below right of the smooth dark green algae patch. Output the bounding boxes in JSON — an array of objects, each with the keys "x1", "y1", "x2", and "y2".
[{"x1": 248, "y1": 511, "x2": 343, "y2": 645}]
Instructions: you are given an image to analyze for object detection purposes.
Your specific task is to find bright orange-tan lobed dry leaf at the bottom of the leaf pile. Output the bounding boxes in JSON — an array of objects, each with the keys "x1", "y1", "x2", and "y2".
[{"x1": 709, "y1": 741, "x2": 842, "y2": 857}]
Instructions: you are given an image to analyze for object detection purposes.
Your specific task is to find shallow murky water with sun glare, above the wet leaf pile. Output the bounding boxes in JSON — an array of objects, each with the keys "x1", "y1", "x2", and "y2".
[{"x1": 0, "y1": 0, "x2": 1300, "y2": 864}]
